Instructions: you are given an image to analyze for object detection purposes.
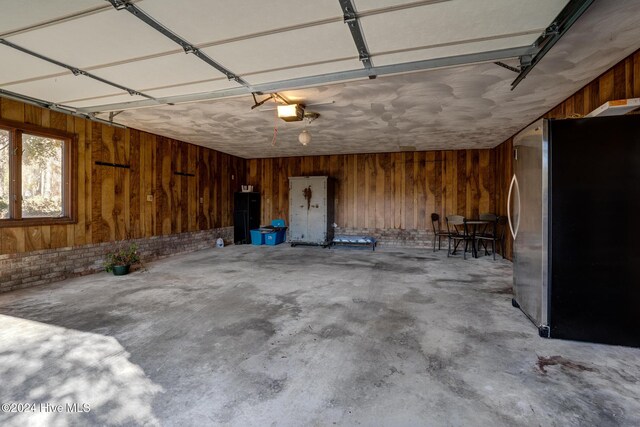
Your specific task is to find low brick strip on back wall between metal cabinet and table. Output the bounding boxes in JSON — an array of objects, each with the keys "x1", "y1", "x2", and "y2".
[{"x1": 335, "y1": 227, "x2": 438, "y2": 249}]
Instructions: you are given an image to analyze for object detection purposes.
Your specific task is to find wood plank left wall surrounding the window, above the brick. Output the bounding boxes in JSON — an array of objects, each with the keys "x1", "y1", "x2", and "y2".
[{"x1": 0, "y1": 98, "x2": 245, "y2": 254}]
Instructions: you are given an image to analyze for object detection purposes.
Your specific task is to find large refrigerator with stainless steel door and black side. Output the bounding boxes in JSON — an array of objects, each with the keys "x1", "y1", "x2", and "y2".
[{"x1": 507, "y1": 115, "x2": 640, "y2": 347}]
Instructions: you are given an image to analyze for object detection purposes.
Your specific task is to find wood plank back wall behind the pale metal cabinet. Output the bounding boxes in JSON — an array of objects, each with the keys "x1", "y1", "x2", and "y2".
[{"x1": 247, "y1": 150, "x2": 495, "y2": 230}]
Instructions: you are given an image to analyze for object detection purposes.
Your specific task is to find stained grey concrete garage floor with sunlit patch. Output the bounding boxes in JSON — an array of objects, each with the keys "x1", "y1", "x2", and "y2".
[{"x1": 0, "y1": 245, "x2": 640, "y2": 426}]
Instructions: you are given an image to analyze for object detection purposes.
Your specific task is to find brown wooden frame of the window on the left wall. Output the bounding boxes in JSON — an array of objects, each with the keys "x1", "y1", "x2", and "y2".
[{"x1": 0, "y1": 119, "x2": 78, "y2": 228}]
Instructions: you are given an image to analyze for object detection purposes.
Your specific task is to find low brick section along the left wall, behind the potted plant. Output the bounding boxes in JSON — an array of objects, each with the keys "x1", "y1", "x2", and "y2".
[{"x1": 0, "y1": 227, "x2": 233, "y2": 292}]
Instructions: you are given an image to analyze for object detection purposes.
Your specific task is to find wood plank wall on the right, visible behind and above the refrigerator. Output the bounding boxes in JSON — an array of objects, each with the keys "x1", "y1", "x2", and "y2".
[{"x1": 494, "y1": 50, "x2": 640, "y2": 258}]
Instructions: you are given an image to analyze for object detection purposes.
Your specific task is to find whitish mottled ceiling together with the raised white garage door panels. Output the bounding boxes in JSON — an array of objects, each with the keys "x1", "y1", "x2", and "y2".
[{"x1": 0, "y1": 0, "x2": 640, "y2": 158}]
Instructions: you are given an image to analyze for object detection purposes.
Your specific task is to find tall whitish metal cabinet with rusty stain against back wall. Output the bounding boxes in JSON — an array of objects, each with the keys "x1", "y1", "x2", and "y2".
[{"x1": 289, "y1": 176, "x2": 334, "y2": 246}]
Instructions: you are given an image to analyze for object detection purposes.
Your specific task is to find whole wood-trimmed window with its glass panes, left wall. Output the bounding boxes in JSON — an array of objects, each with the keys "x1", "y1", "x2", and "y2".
[{"x1": 0, "y1": 121, "x2": 75, "y2": 227}]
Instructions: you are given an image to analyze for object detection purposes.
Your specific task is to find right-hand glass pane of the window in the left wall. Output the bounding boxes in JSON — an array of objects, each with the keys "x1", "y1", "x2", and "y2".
[{"x1": 22, "y1": 133, "x2": 64, "y2": 218}]
